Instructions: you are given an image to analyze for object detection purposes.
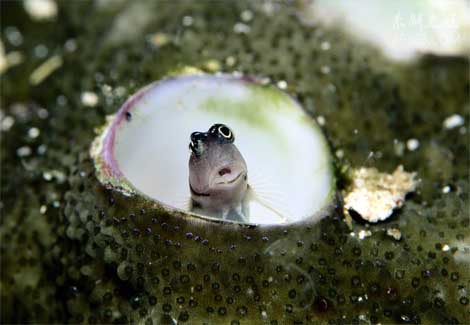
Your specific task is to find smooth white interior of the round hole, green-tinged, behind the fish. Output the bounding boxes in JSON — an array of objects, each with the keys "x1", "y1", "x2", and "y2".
[{"x1": 114, "y1": 75, "x2": 334, "y2": 224}]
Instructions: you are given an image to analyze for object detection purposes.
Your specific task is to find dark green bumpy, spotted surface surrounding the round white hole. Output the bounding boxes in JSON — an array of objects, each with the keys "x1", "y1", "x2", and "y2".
[{"x1": 0, "y1": 1, "x2": 470, "y2": 324}]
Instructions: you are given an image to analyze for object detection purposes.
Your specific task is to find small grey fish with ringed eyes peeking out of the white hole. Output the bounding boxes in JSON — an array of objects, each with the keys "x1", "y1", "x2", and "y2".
[{"x1": 188, "y1": 123, "x2": 289, "y2": 223}]
